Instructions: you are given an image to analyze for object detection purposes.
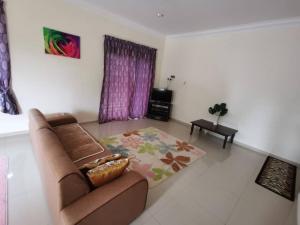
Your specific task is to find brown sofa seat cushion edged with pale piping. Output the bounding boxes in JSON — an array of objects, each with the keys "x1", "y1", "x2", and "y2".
[{"x1": 53, "y1": 123, "x2": 106, "y2": 166}]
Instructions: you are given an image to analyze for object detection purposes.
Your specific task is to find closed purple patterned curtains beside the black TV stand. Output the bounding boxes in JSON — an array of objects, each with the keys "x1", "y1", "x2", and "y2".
[{"x1": 99, "y1": 36, "x2": 156, "y2": 123}]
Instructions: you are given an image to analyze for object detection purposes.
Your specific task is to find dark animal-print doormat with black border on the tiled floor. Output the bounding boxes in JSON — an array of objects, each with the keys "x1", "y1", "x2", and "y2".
[{"x1": 255, "y1": 156, "x2": 297, "y2": 201}]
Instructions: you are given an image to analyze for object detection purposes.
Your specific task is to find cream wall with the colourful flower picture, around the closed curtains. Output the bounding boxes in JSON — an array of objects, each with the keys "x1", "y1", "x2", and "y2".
[{"x1": 0, "y1": 0, "x2": 164, "y2": 136}]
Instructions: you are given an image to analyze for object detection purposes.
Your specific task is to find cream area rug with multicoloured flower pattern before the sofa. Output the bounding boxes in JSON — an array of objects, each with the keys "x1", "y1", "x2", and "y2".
[{"x1": 100, "y1": 127, "x2": 205, "y2": 188}]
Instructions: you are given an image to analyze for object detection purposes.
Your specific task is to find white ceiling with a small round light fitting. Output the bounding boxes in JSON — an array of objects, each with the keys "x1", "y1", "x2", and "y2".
[{"x1": 81, "y1": 0, "x2": 300, "y2": 34}]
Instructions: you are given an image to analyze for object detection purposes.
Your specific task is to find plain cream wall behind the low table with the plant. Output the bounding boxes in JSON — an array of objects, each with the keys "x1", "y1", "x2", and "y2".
[{"x1": 160, "y1": 25, "x2": 300, "y2": 163}]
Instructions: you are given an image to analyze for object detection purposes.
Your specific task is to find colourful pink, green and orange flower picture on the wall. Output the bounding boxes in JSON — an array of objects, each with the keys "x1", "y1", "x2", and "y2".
[{"x1": 43, "y1": 27, "x2": 80, "y2": 59}]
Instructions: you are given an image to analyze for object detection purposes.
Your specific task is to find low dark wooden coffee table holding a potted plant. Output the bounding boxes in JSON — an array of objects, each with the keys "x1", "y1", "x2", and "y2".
[{"x1": 190, "y1": 119, "x2": 238, "y2": 148}]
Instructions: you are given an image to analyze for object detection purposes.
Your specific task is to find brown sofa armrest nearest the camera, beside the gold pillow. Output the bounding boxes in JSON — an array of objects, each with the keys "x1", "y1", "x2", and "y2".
[{"x1": 61, "y1": 171, "x2": 148, "y2": 225}]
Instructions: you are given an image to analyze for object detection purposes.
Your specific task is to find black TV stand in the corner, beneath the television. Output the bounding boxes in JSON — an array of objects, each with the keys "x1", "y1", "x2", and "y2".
[{"x1": 147, "y1": 100, "x2": 172, "y2": 121}]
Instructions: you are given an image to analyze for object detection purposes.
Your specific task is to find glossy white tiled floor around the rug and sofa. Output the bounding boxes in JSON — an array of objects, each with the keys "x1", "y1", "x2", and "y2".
[{"x1": 0, "y1": 119, "x2": 299, "y2": 225}]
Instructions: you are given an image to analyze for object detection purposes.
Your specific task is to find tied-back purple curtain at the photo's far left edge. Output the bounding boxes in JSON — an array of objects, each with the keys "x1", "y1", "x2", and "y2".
[{"x1": 0, "y1": 1, "x2": 19, "y2": 115}]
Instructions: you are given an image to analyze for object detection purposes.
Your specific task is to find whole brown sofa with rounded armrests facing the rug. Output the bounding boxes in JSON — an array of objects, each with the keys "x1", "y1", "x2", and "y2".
[{"x1": 29, "y1": 109, "x2": 148, "y2": 225}]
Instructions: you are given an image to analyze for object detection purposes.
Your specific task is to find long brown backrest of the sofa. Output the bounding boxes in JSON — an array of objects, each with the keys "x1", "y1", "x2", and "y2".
[{"x1": 29, "y1": 109, "x2": 90, "y2": 223}]
